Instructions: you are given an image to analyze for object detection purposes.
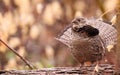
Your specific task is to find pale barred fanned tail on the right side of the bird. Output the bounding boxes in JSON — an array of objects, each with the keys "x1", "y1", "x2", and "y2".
[{"x1": 87, "y1": 19, "x2": 117, "y2": 47}]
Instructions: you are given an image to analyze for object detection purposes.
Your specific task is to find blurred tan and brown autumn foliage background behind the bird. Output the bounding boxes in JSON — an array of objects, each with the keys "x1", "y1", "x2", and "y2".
[{"x1": 0, "y1": 0, "x2": 120, "y2": 70}]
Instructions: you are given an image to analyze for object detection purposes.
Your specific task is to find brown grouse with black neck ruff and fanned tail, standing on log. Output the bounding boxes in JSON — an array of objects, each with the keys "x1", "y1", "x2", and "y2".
[{"x1": 56, "y1": 17, "x2": 117, "y2": 71}]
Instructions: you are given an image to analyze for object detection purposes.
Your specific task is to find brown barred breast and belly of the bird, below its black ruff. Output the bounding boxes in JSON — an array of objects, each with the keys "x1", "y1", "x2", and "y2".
[{"x1": 70, "y1": 37, "x2": 104, "y2": 63}]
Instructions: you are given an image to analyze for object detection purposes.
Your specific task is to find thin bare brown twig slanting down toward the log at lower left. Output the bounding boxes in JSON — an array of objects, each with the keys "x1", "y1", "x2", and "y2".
[{"x1": 0, "y1": 38, "x2": 33, "y2": 69}]
